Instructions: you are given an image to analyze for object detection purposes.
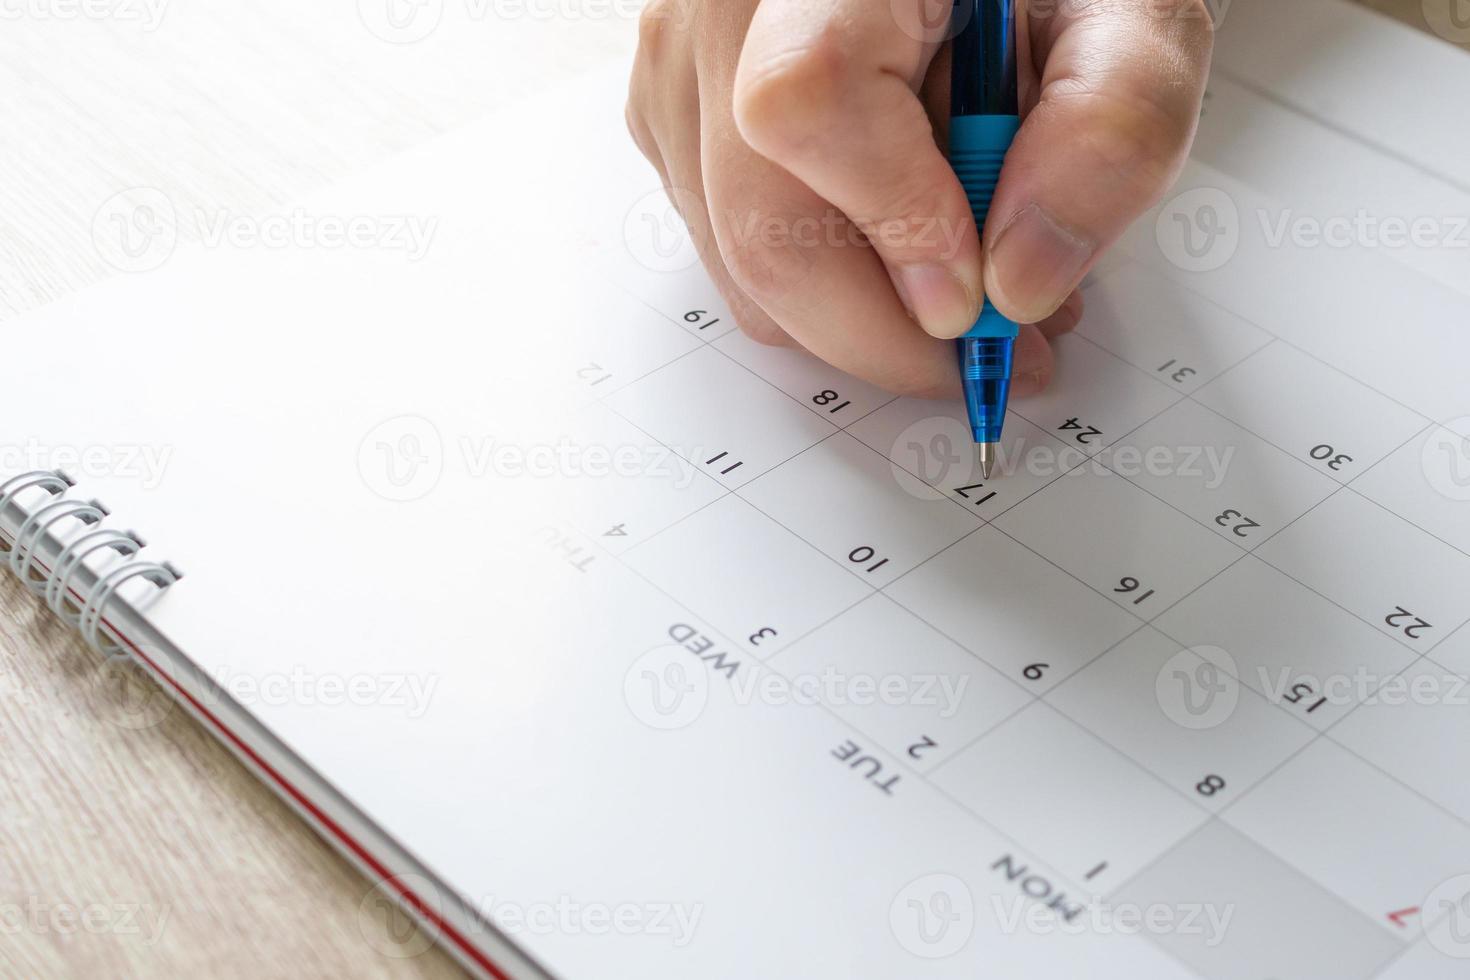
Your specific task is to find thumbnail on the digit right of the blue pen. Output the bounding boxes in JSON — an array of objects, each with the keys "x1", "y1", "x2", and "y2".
[{"x1": 985, "y1": 204, "x2": 1097, "y2": 323}]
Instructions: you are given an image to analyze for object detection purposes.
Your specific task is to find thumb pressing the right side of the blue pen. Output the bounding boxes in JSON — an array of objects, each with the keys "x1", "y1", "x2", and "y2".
[{"x1": 985, "y1": 0, "x2": 1214, "y2": 323}]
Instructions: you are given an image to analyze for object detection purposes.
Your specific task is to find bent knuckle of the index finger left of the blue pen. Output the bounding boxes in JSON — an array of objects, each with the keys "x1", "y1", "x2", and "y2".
[{"x1": 735, "y1": 32, "x2": 853, "y2": 154}]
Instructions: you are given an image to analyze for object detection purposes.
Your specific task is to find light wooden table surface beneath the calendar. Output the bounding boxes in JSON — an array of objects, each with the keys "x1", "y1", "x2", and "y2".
[{"x1": 0, "y1": 0, "x2": 1439, "y2": 980}]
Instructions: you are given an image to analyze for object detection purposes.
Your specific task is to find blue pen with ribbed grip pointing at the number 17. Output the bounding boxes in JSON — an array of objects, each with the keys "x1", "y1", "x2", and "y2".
[{"x1": 950, "y1": 0, "x2": 1020, "y2": 479}]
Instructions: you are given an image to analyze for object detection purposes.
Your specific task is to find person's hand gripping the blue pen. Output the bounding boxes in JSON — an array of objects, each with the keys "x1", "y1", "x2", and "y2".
[{"x1": 628, "y1": 0, "x2": 1213, "y2": 397}]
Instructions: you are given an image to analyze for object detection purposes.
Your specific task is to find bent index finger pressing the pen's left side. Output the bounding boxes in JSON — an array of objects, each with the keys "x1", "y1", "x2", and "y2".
[{"x1": 735, "y1": 0, "x2": 983, "y2": 338}]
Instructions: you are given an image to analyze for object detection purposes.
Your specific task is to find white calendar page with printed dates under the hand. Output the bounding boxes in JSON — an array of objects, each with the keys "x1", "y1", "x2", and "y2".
[{"x1": 0, "y1": 0, "x2": 1470, "y2": 980}]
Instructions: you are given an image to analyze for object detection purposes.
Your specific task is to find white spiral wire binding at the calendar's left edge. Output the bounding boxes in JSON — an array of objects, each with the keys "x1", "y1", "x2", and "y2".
[{"x1": 0, "y1": 470, "x2": 184, "y2": 657}]
